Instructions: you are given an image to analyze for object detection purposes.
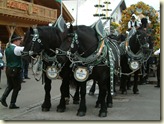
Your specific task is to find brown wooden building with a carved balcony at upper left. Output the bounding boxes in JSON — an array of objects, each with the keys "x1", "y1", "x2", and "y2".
[{"x1": 0, "y1": 0, "x2": 74, "y2": 50}]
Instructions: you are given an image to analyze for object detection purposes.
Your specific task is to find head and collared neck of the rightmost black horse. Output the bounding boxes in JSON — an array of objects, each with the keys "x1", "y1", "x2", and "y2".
[{"x1": 124, "y1": 29, "x2": 152, "y2": 68}]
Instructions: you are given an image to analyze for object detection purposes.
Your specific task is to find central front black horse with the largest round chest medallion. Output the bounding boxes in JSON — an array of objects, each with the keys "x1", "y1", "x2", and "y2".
[{"x1": 56, "y1": 22, "x2": 121, "y2": 117}]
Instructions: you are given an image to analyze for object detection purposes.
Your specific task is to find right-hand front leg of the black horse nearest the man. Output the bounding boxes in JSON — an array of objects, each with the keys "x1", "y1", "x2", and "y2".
[{"x1": 57, "y1": 77, "x2": 69, "y2": 112}]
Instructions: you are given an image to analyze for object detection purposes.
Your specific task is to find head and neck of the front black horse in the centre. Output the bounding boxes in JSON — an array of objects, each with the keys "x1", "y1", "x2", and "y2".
[{"x1": 56, "y1": 25, "x2": 98, "y2": 66}]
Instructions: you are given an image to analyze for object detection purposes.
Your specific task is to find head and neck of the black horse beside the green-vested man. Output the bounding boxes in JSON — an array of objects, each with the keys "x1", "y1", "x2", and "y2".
[{"x1": 23, "y1": 26, "x2": 67, "y2": 56}]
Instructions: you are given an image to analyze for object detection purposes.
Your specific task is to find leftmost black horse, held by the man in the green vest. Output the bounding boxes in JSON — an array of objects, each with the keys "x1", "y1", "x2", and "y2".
[{"x1": 23, "y1": 22, "x2": 76, "y2": 111}]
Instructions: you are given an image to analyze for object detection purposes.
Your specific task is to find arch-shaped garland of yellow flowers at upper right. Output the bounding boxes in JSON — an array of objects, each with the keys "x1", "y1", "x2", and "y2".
[{"x1": 120, "y1": 2, "x2": 160, "y2": 50}]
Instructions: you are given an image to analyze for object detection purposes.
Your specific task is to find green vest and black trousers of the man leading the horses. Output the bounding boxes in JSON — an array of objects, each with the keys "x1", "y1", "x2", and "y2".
[{"x1": 5, "y1": 44, "x2": 22, "y2": 103}]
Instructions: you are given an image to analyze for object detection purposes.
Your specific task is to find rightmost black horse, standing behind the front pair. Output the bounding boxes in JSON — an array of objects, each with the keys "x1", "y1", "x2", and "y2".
[{"x1": 120, "y1": 29, "x2": 152, "y2": 94}]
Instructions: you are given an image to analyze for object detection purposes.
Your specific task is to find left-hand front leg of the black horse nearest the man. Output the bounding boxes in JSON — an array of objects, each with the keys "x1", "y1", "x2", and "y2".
[{"x1": 42, "y1": 76, "x2": 51, "y2": 111}]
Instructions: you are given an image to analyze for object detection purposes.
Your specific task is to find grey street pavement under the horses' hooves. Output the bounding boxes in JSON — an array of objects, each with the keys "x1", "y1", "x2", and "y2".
[{"x1": 0, "y1": 69, "x2": 162, "y2": 122}]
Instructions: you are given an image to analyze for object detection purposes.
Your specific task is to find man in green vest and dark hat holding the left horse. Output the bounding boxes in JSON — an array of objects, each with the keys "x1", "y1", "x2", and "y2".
[{"x1": 0, "y1": 34, "x2": 24, "y2": 109}]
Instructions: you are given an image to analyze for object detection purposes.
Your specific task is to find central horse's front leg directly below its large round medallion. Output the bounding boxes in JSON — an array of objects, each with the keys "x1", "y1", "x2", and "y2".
[{"x1": 77, "y1": 82, "x2": 87, "y2": 117}]
